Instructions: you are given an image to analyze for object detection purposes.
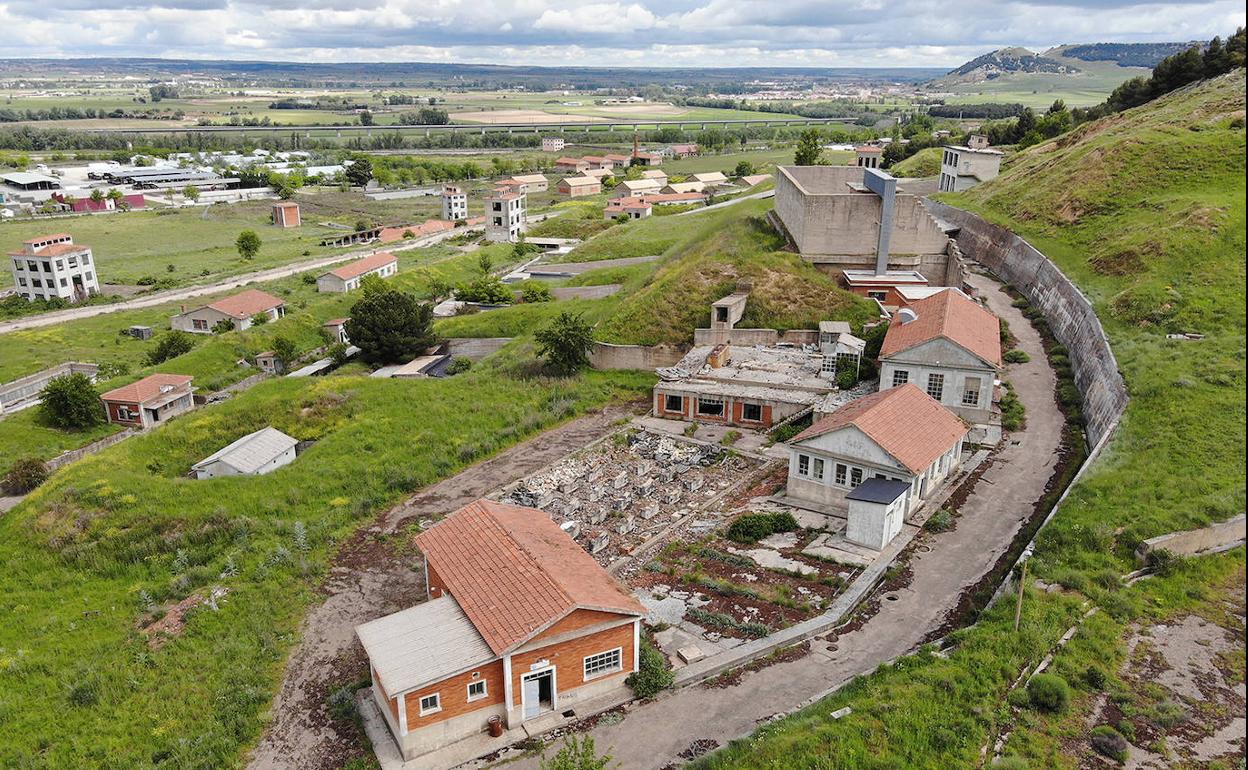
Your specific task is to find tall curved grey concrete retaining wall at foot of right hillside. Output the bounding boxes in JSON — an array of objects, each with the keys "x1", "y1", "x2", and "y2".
[{"x1": 926, "y1": 201, "x2": 1127, "y2": 446}]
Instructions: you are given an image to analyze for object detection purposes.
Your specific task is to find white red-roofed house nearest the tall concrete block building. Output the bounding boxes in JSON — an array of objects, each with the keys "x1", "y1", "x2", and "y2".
[{"x1": 880, "y1": 291, "x2": 1002, "y2": 424}]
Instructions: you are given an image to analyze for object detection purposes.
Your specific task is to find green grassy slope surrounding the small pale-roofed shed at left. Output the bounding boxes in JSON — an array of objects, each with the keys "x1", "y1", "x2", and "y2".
[{"x1": 0, "y1": 346, "x2": 650, "y2": 770}]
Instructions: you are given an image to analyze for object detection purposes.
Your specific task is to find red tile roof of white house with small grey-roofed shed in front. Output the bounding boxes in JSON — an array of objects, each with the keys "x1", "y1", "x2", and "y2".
[{"x1": 790, "y1": 382, "x2": 966, "y2": 473}]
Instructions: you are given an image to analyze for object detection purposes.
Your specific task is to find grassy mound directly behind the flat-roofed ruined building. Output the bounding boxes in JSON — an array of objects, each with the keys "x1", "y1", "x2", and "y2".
[{"x1": 598, "y1": 201, "x2": 874, "y2": 344}]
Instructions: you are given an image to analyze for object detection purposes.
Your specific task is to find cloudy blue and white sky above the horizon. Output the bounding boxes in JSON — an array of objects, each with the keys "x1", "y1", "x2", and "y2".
[{"x1": 0, "y1": 0, "x2": 1244, "y2": 66}]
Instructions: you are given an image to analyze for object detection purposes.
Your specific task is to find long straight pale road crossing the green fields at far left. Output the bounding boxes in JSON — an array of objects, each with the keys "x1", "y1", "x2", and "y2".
[{"x1": 0, "y1": 230, "x2": 476, "y2": 334}]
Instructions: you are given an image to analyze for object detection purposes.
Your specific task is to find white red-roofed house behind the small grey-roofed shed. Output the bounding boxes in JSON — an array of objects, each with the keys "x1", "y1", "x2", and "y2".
[{"x1": 785, "y1": 383, "x2": 967, "y2": 534}]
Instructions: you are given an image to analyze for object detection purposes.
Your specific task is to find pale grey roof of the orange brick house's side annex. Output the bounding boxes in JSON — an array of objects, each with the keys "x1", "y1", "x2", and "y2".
[{"x1": 356, "y1": 595, "x2": 497, "y2": 696}]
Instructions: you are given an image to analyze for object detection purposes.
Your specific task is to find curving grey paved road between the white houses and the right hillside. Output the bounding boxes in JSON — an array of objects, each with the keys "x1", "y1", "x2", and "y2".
[{"x1": 496, "y1": 276, "x2": 1063, "y2": 770}]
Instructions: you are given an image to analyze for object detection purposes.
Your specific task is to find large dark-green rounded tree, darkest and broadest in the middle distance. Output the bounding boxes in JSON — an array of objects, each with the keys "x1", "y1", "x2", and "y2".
[{"x1": 347, "y1": 288, "x2": 436, "y2": 364}]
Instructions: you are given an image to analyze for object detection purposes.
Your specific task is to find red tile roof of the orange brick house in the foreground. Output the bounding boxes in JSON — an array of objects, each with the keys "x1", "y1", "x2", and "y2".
[{"x1": 416, "y1": 499, "x2": 645, "y2": 655}]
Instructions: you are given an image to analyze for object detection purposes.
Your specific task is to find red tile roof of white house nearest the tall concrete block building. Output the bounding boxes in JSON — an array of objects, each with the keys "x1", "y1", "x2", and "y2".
[{"x1": 880, "y1": 291, "x2": 1001, "y2": 367}]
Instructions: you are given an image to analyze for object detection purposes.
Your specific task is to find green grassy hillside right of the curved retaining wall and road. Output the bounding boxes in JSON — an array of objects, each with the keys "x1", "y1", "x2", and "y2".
[{"x1": 700, "y1": 70, "x2": 1244, "y2": 770}]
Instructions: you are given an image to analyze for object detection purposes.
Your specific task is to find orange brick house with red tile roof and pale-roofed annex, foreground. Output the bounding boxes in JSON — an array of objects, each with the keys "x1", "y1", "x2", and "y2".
[{"x1": 356, "y1": 499, "x2": 645, "y2": 759}]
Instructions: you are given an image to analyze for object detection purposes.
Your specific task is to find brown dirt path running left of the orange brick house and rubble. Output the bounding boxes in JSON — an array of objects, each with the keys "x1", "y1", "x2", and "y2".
[{"x1": 248, "y1": 407, "x2": 633, "y2": 770}]
